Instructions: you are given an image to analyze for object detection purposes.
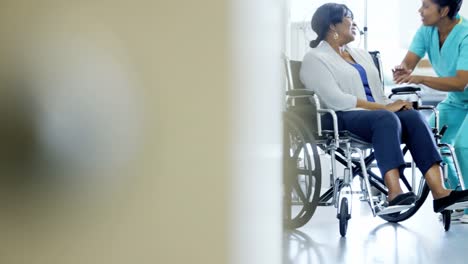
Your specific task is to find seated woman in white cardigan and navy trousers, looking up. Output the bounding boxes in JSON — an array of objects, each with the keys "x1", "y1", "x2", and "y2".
[{"x1": 300, "y1": 3, "x2": 468, "y2": 212}]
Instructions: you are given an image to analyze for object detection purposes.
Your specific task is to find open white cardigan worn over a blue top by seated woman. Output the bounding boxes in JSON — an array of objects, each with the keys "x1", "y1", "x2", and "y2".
[{"x1": 300, "y1": 41, "x2": 391, "y2": 111}]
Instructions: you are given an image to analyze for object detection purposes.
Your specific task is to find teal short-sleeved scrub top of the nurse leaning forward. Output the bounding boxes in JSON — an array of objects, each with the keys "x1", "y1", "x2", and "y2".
[{"x1": 409, "y1": 15, "x2": 468, "y2": 104}]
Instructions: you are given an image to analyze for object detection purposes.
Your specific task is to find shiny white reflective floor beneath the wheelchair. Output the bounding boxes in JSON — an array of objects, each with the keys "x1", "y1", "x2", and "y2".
[{"x1": 284, "y1": 192, "x2": 468, "y2": 264}]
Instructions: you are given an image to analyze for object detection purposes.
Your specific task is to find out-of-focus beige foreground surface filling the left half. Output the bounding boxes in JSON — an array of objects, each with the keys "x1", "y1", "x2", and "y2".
[{"x1": 0, "y1": 0, "x2": 231, "y2": 264}]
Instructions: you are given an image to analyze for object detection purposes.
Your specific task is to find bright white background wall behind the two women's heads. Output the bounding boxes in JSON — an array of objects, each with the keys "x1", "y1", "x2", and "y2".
[{"x1": 288, "y1": 0, "x2": 468, "y2": 80}]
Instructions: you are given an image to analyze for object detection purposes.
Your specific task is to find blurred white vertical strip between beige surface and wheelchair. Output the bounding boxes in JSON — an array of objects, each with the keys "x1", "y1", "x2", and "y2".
[{"x1": 229, "y1": 0, "x2": 286, "y2": 264}]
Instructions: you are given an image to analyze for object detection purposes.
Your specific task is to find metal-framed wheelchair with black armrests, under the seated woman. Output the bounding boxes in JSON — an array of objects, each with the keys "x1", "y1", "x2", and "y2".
[{"x1": 283, "y1": 51, "x2": 468, "y2": 237}]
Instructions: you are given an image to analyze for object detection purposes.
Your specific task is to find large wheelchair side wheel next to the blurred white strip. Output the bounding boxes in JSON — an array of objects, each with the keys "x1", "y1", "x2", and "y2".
[{"x1": 283, "y1": 112, "x2": 321, "y2": 228}]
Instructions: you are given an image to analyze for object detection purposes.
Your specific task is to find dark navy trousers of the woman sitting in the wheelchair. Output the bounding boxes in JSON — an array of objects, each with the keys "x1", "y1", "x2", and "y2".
[{"x1": 322, "y1": 110, "x2": 442, "y2": 177}]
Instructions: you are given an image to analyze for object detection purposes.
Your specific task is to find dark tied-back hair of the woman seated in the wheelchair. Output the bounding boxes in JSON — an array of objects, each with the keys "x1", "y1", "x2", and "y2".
[{"x1": 309, "y1": 3, "x2": 354, "y2": 48}]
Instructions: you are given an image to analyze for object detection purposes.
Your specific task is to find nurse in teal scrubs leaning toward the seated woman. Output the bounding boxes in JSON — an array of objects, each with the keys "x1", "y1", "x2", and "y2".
[{"x1": 393, "y1": 0, "x2": 468, "y2": 223}]
